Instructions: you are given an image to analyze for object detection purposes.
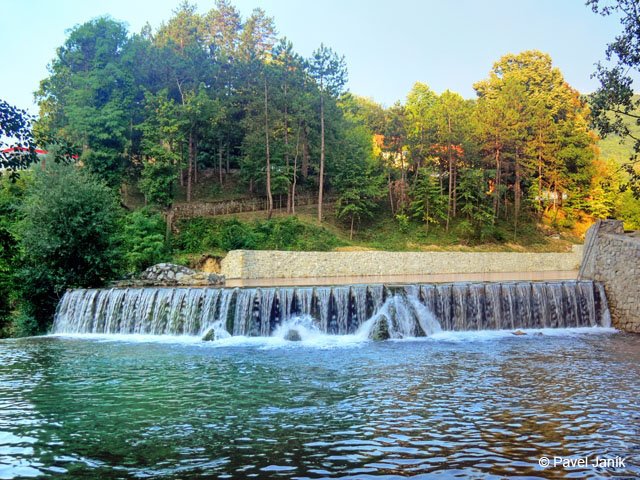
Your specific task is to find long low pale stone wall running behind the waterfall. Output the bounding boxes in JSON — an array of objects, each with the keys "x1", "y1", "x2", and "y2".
[{"x1": 221, "y1": 245, "x2": 582, "y2": 279}]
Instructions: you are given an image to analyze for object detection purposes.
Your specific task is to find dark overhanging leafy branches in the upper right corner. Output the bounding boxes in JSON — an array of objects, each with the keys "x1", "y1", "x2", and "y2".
[{"x1": 587, "y1": 0, "x2": 640, "y2": 198}]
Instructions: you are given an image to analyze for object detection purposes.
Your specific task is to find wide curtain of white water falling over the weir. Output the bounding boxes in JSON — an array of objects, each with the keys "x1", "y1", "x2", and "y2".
[{"x1": 53, "y1": 281, "x2": 611, "y2": 339}]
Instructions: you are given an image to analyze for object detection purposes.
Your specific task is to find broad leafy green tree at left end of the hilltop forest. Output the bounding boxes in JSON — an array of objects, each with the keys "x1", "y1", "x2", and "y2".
[{"x1": 36, "y1": 17, "x2": 134, "y2": 186}]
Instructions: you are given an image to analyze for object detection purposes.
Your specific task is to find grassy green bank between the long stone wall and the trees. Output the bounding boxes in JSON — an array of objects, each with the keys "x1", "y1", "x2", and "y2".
[{"x1": 168, "y1": 207, "x2": 579, "y2": 266}]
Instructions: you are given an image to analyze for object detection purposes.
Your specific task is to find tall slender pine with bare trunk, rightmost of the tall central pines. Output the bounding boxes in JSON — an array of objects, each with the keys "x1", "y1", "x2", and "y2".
[{"x1": 309, "y1": 44, "x2": 347, "y2": 222}]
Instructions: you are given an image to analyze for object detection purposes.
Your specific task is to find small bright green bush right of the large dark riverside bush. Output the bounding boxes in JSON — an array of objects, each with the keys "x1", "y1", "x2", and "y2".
[{"x1": 121, "y1": 208, "x2": 167, "y2": 273}]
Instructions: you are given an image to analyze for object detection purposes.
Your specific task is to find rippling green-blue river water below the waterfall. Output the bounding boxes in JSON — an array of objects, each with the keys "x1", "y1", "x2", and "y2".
[{"x1": 0, "y1": 329, "x2": 640, "y2": 479}]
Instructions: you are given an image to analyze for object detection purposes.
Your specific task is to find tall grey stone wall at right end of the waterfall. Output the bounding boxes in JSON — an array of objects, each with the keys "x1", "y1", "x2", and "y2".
[{"x1": 580, "y1": 220, "x2": 640, "y2": 333}]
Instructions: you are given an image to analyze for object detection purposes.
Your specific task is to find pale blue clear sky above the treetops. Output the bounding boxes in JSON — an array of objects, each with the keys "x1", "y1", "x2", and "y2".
[{"x1": 0, "y1": 0, "x2": 621, "y2": 114}]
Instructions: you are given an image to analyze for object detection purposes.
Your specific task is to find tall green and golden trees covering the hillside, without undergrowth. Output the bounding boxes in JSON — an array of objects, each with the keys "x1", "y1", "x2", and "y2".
[{"x1": 35, "y1": 1, "x2": 636, "y2": 229}]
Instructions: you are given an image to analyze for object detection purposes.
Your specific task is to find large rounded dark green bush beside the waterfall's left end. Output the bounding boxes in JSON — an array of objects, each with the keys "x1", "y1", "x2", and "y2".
[{"x1": 17, "y1": 164, "x2": 120, "y2": 331}]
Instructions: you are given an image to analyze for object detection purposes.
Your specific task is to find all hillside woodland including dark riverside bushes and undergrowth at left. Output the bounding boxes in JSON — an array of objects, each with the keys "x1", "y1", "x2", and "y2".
[{"x1": 0, "y1": 0, "x2": 640, "y2": 334}]
